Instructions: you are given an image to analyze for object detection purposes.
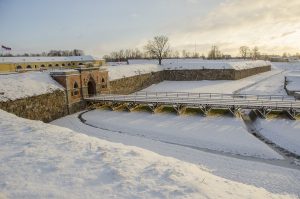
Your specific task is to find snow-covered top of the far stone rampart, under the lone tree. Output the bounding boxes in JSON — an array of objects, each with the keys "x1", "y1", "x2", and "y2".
[{"x1": 108, "y1": 59, "x2": 271, "y2": 80}]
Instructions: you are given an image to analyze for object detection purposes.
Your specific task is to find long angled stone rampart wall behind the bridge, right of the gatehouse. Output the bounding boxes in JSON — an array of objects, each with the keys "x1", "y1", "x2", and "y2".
[{"x1": 110, "y1": 66, "x2": 271, "y2": 94}]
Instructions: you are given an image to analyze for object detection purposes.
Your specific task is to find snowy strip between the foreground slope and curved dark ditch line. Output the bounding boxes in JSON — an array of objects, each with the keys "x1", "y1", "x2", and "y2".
[{"x1": 52, "y1": 114, "x2": 300, "y2": 195}]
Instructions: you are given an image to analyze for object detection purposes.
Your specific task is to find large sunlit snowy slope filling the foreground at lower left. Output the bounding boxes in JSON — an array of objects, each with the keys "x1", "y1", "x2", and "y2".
[{"x1": 0, "y1": 111, "x2": 295, "y2": 198}]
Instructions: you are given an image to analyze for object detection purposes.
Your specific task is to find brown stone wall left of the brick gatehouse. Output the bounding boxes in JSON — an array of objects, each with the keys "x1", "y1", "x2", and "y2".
[{"x1": 0, "y1": 91, "x2": 68, "y2": 122}]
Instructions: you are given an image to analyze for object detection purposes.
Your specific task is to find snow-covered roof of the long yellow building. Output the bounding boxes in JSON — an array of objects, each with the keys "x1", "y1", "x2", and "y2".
[{"x1": 0, "y1": 55, "x2": 103, "y2": 63}]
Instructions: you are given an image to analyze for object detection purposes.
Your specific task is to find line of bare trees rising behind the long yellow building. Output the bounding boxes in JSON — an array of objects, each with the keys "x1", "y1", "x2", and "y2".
[{"x1": 0, "y1": 49, "x2": 84, "y2": 57}]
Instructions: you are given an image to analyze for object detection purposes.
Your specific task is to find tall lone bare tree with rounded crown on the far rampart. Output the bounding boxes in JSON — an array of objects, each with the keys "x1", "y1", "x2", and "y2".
[{"x1": 145, "y1": 35, "x2": 170, "y2": 65}]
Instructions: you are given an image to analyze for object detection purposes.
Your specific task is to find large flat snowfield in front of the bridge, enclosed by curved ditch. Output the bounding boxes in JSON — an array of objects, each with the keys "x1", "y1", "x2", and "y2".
[{"x1": 79, "y1": 110, "x2": 282, "y2": 159}]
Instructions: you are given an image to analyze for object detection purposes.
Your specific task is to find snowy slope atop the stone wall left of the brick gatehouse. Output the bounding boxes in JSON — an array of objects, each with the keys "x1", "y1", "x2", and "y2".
[{"x1": 0, "y1": 72, "x2": 63, "y2": 101}]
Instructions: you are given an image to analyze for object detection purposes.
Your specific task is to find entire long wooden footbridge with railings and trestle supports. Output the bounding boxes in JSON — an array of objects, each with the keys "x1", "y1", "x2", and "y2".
[{"x1": 85, "y1": 92, "x2": 300, "y2": 119}]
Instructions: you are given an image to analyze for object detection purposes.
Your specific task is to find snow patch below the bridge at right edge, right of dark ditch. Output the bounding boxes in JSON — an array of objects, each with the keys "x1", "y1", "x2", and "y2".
[{"x1": 255, "y1": 119, "x2": 300, "y2": 155}]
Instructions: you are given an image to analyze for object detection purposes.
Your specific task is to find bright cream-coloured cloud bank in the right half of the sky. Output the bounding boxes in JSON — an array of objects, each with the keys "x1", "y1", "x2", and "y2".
[{"x1": 171, "y1": 0, "x2": 300, "y2": 54}]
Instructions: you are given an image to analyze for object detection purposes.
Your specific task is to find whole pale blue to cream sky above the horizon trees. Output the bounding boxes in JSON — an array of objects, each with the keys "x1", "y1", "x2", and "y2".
[{"x1": 0, "y1": 0, "x2": 300, "y2": 57}]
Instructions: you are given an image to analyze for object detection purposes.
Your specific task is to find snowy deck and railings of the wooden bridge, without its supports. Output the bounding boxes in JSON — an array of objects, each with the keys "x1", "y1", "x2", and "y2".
[{"x1": 85, "y1": 92, "x2": 300, "y2": 113}]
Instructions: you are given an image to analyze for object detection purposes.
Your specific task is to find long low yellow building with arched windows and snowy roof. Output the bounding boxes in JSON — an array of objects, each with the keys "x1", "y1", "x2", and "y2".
[{"x1": 0, "y1": 55, "x2": 105, "y2": 72}]
